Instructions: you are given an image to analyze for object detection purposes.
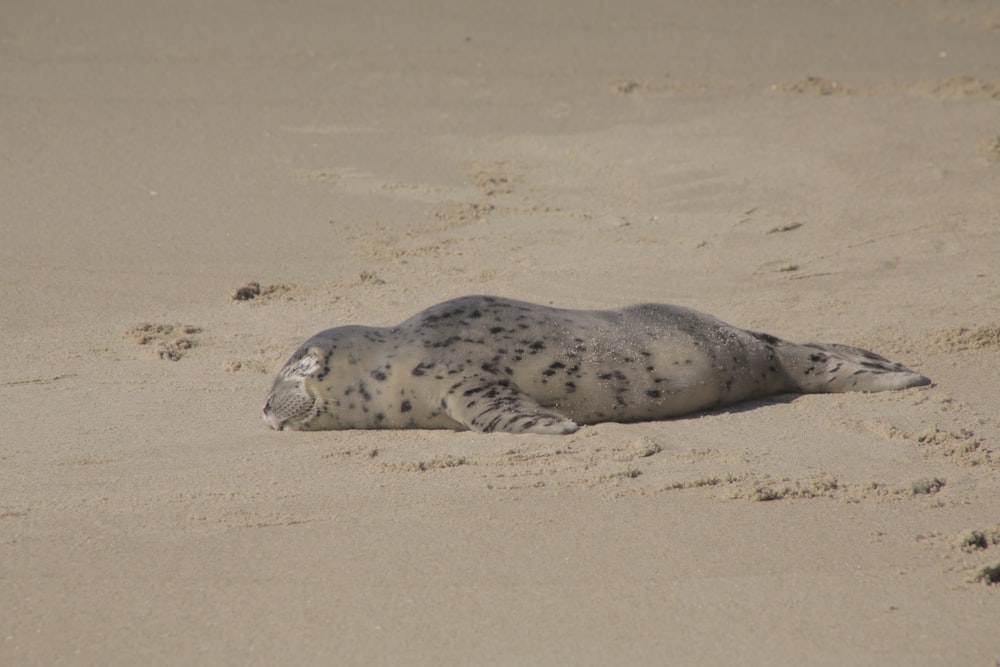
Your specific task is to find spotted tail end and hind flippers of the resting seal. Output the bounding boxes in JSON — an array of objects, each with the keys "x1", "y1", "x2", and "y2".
[{"x1": 777, "y1": 343, "x2": 931, "y2": 394}]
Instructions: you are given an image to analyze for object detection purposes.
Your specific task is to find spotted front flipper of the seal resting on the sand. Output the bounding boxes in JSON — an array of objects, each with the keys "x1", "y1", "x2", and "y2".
[{"x1": 441, "y1": 375, "x2": 579, "y2": 435}]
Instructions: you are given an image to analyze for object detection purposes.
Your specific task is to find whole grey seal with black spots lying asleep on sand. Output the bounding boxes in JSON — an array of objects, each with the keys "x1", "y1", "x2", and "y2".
[{"x1": 264, "y1": 296, "x2": 930, "y2": 435}]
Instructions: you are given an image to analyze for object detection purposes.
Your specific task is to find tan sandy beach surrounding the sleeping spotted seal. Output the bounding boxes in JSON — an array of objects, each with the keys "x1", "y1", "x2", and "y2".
[{"x1": 0, "y1": 0, "x2": 1000, "y2": 666}]
